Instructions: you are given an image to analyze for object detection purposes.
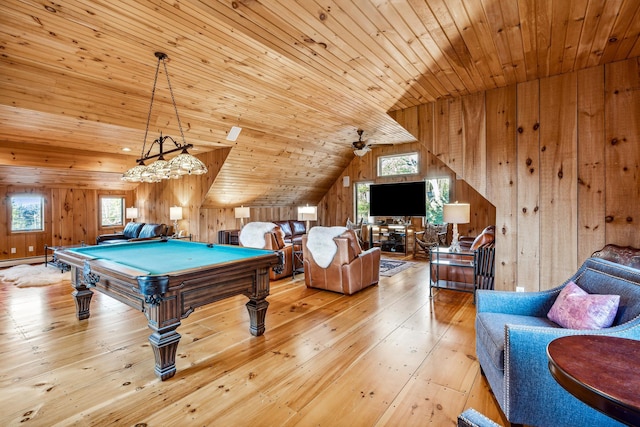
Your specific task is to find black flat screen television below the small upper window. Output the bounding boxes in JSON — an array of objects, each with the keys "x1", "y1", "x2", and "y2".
[{"x1": 369, "y1": 181, "x2": 427, "y2": 217}]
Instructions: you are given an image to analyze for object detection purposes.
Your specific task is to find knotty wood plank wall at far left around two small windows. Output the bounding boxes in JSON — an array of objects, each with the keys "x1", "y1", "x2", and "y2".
[{"x1": 0, "y1": 186, "x2": 134, "y2": 260}]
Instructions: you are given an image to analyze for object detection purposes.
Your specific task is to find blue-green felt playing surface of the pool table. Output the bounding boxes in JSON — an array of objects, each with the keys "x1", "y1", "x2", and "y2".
[{"x1": 69, "y1": 239, "x2": 273, "y2": 274}]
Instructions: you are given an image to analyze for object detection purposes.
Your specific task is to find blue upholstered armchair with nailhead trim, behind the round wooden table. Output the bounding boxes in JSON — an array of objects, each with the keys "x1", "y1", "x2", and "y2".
[{"x1": 476, "y1": 257, "x2": 640, "y2": 427}]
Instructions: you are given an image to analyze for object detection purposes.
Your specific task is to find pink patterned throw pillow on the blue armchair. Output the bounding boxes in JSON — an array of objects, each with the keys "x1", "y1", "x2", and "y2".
[{"x1": 547, "y1": 282, "x2": 620, "y2": 329}]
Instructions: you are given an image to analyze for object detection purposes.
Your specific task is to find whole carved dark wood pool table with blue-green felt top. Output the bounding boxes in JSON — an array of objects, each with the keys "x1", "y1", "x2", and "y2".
[{"x1": 55, "y1": 239, "x2": 283, "y2": 381}]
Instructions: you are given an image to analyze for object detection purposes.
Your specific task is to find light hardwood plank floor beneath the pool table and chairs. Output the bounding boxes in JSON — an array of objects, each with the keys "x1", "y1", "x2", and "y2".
[{"x1": 0, "y1": 262, "x2": 504, "y2": 426}]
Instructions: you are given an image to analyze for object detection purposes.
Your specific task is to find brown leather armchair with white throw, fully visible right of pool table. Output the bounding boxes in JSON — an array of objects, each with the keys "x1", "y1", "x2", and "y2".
[{"x1": 302, "y1": 227, "x2": 380, "y2": 295}]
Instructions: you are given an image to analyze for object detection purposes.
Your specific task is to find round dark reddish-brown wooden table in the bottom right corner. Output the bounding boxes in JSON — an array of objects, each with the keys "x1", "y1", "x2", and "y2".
[{"x1": 547, "y1": 335, "x2": 640, "y2": 426}]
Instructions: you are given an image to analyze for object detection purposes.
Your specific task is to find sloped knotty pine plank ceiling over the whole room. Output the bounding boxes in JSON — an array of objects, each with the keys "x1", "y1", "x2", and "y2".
[{"x1": 0, "y1": 0, "x2": 640, "y2": 207}]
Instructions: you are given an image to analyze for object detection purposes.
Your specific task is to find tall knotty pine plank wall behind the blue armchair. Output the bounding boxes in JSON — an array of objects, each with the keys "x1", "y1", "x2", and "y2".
[{"x1": 392, "y1": 58, "x2": 640, "y2": 291}]
